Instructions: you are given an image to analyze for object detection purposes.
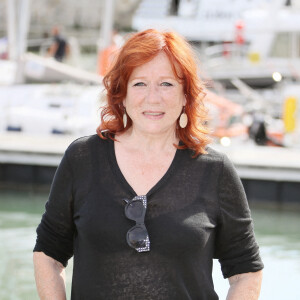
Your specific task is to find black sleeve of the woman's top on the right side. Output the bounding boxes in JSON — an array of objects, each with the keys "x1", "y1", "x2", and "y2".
[{"x1": 214, "y1": 156, "x2": 263, "y2": 278}]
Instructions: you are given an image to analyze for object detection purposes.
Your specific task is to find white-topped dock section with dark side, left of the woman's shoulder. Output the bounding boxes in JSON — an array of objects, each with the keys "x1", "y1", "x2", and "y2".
[{"x1": 0, "y1": 132, "x2": 77, "y2": 190}]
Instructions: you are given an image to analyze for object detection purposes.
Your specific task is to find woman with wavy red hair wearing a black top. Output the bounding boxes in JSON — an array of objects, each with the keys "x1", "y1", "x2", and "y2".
[{"x1": 34, "y1": 30, "x2": 263, "y2": 300}]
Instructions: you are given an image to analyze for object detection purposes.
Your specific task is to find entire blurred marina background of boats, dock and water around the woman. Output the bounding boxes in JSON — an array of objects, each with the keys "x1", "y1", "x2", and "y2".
[{"x1": 0, "y1": 0, "x2": 300, "y2": 300}]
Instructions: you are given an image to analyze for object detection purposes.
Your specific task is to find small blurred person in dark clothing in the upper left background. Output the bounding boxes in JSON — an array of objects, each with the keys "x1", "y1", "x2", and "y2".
[{"x1": 48, "y1": 26, "x2": 70, "y2": 62}]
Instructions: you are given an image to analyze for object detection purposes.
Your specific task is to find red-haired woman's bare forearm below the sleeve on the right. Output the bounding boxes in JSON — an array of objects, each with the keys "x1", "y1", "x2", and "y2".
[{"x1": 226, "y1": 270, "x2": 262, "y2": 300}]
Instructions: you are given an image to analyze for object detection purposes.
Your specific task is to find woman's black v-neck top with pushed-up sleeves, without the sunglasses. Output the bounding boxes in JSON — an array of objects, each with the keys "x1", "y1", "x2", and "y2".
[{"x1": 34, "y1": 135, "x2": 263, "y2": 300}]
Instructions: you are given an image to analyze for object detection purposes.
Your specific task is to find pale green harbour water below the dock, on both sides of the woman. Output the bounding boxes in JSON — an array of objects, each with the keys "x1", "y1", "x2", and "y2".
[{"x1": 0, "y1": 191, "x2": 300, "y2": 300}]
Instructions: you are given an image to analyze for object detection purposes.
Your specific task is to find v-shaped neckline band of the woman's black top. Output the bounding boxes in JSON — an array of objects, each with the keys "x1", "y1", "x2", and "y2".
[{"x1": 108, "y1": 139, "x2": 183, "y2": 198}]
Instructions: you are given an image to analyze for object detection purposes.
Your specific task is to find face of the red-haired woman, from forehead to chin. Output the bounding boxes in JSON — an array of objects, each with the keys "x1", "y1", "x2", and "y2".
[{"x1": 123, "y1": 52, "x2": 186, "y2": 134}]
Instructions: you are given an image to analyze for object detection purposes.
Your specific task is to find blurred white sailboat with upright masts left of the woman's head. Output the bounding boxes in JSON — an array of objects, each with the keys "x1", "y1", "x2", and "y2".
[{"x1": 0, "y1": 0, "x2": 118, "y2": 138}]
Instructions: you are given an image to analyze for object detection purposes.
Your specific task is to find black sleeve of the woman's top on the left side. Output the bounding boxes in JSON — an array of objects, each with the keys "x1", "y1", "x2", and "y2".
[{"x1": 33, "y1": 152, "x2": 74, "y2": 267}]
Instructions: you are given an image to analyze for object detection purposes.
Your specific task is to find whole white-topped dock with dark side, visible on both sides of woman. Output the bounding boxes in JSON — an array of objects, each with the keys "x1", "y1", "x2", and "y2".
[{"x1": 0, "y1": 133, "x2": 300, "y2": 207}]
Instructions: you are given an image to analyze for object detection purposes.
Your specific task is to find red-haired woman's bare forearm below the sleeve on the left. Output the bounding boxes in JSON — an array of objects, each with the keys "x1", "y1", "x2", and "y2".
[{"x1": 33, "y1": 252, "x2": 66, "y2": 300}]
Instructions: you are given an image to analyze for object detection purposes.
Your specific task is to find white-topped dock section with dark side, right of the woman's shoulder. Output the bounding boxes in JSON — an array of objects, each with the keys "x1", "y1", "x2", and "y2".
[{"x1": 213, "y1": 144, "x2": 300, "y2": 209}]
